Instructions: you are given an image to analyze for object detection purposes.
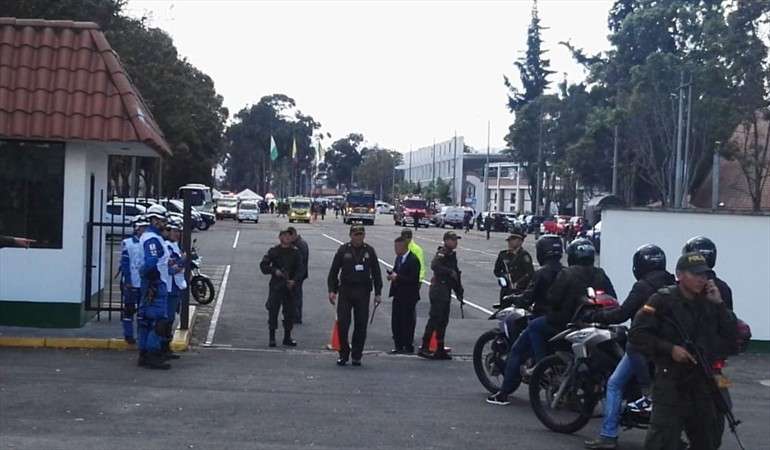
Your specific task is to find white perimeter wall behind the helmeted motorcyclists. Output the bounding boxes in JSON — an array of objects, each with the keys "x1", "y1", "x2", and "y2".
[{"x1": 601, "y1": 209, "x2": 770, "y2": 341}]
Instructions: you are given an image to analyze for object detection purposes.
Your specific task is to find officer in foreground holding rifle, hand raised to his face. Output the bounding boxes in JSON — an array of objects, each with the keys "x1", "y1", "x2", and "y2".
[{"x1": 629, "y1": 252, "x2": 736, "y2": 450}]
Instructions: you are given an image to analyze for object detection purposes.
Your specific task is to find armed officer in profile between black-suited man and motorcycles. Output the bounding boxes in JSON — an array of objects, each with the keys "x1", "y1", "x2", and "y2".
[{"x1": 417, "y1": 231, "x2": 465, "y2": 359}]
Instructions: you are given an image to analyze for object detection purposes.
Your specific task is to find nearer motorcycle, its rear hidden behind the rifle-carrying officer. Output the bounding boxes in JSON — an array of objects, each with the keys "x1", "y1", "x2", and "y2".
[{"x1": 529, "y1": 288, "x2": 650, "y2": 433}]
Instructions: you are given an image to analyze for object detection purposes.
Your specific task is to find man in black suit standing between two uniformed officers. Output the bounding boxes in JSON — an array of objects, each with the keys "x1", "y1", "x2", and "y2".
[{"x1": 388, "y1": 236, "x2": 420, "y2": 354}]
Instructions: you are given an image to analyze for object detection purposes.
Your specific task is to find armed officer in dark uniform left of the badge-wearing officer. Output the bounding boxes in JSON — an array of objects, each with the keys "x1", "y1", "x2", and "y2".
[{"x1": 259, "y1": 230, "x2": 305, "y2": 347}]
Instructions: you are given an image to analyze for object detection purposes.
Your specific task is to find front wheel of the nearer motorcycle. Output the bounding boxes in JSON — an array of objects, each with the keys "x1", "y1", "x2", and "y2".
[{"x1": 529, "y1": 355, "x2": 596, "y2": 434}]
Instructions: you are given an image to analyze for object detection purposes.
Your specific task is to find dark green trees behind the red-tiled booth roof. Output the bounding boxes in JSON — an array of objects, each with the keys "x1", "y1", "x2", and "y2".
[{"x1": 6, "y1": 0, "x2": 228, "y2": 195}]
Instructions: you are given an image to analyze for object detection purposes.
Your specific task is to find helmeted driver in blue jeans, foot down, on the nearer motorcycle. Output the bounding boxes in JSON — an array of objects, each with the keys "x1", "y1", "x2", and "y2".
[{"x1": 585, "y1": 244, "x2": 676, "y2": 449}]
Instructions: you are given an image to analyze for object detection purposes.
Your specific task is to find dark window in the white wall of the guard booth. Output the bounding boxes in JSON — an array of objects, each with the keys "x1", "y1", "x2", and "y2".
[{"x1": 0, "y1": 140, "x2": 64, "y2": 248}]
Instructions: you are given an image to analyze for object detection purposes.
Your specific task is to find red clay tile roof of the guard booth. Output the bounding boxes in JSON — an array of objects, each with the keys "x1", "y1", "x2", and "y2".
[{"x1": 0, "y1": 17, "x2": 171, "y2": 155}]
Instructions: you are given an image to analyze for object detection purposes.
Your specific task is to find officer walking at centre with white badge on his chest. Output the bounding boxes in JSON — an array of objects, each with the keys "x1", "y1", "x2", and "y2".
[{"x1": 327, "y1": 225, "x2": 382, "y2": 366}]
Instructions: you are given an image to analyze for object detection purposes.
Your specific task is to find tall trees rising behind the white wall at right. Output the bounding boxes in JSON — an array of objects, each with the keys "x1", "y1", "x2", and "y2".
[{"x1": 505, "y1": 0, "x2": 770, "y2": 210}]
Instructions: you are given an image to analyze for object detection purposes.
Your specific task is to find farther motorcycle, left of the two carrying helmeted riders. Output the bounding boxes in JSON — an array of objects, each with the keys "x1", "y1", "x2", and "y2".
[{"x1": 473, "y1": 277, "x2": 532, "y2": 394}]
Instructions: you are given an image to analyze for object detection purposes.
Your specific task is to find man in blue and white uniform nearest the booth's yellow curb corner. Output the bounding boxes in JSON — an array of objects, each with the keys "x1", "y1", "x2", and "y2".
[{"x1": 137, "y1": 205, "x2": 171, "y2": 370}]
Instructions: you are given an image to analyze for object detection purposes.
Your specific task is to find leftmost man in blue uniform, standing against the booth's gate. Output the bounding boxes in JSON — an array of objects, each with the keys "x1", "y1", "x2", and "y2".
[{"x1": 120, "y1": 216, "x2": 149, "y2": 345}]
